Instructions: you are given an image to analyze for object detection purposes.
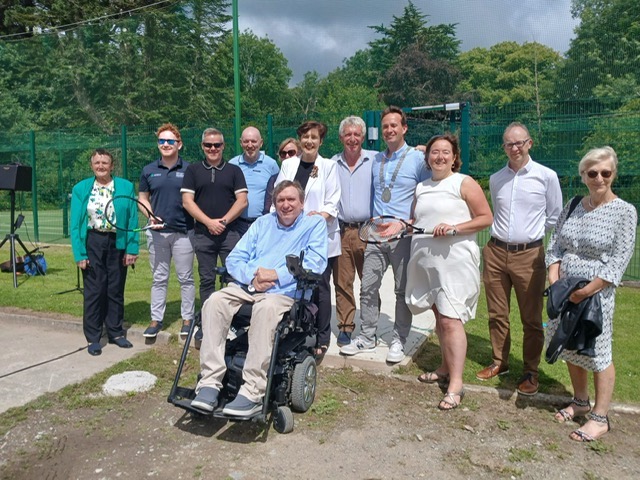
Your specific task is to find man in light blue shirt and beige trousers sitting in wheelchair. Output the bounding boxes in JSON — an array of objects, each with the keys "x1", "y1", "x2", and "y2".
[{"x1": 191, "y1": 180, "x2": 328, "y2": 417}]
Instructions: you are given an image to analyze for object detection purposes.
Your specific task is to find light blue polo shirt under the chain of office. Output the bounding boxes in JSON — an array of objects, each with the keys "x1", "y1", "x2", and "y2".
[{"x1": 371, "y1": 143, "x2": 431, "y2": 220}]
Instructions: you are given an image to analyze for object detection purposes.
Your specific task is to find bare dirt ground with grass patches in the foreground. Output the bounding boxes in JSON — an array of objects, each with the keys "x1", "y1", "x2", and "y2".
[{"x1": 0, "y1": 345, "x2": 640, "y2": 480}]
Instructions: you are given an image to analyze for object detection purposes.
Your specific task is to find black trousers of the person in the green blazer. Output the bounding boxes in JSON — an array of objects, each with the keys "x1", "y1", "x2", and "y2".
[{"x1": 82, "y1": 230, "x2": 127, "y2": 343}]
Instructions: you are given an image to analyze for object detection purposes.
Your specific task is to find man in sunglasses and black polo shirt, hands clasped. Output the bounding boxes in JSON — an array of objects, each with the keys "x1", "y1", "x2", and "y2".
[{"x1": 180, "y1": 128, "x2": 248, "y2": 304}]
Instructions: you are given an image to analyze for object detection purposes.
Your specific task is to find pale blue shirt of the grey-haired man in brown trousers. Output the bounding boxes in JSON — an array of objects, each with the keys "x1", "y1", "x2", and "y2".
[{"x1": 331, "y1": 150, "x2": 379, "y2": 222}]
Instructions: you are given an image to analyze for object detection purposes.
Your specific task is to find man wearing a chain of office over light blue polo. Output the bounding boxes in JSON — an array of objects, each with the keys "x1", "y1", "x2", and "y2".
[{"x1": 340, "y1": 106, "x2": 430, "y2": 363}]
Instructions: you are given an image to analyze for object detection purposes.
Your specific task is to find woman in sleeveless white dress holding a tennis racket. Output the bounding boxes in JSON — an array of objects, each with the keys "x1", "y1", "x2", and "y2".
[{"x1": 406, "y1": 135, "x2": 493, "y2": 410}]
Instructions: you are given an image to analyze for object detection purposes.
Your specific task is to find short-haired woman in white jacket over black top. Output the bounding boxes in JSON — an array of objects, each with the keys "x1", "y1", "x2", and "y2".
[{"x1": 276, "y1": 120, "x2": 342, "y2": 357}]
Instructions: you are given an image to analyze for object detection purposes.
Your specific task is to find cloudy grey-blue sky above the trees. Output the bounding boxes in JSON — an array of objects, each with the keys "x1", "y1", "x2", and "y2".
[{"x1": 238, "y1": 0, "x2": 577, "y2": 84}]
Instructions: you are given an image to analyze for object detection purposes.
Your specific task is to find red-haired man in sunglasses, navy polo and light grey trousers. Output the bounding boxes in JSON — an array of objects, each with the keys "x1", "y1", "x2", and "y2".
[{"x1": 139, "y1": 123, "x2": 196, "y2": 337}]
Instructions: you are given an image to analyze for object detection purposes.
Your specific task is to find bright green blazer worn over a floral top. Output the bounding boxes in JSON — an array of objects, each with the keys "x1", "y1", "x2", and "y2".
[{"x1": 71, "y1": 177, "x2": 139, "y2": 263}]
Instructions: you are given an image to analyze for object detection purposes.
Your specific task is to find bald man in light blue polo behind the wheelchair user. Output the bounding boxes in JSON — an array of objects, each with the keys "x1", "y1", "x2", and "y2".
[{"x1": 229, "y1": 127, "x2": 280, "y2": 235}]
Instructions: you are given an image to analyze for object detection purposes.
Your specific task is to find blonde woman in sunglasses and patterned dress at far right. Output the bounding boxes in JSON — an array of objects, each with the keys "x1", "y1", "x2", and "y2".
[{"x1": 546, "y1": 147, "x2": 638, "y2": 442}]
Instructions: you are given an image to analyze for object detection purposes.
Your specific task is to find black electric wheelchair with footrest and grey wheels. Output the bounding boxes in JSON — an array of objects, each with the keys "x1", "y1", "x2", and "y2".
[{"x1": 167, "y1": 253, "x2": 321, "y2": 433}]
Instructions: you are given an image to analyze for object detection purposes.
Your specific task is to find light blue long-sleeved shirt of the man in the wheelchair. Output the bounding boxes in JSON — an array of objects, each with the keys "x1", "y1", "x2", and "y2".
[{"x1": 226, "y1": 212, "x2": 329, "y2": 297}]
